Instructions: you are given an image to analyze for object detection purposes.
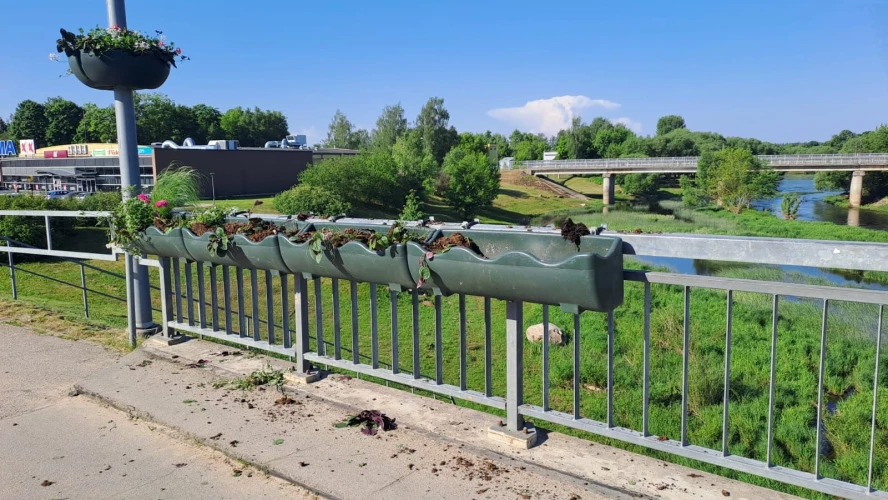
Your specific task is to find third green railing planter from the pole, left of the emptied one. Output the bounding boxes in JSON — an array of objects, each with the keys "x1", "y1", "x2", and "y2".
[{"x1": 278, "y1": 222, "x2": 416, "y2": 289}]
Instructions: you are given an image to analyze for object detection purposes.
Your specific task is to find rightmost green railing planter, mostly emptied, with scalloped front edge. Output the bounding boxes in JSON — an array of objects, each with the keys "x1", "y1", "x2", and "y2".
[{"x1": 407, "y1": 230, "x2": 623, "y2": 312}]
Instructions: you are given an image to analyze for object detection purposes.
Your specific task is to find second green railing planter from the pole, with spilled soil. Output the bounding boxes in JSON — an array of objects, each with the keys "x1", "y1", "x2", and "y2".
[{"x1": 182, "y1": 229, "x2": 289, "y2": 273}]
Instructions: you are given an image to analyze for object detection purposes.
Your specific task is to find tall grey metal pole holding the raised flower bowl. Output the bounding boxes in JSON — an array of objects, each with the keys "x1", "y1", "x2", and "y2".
[{"x1": 107, "y1": 0, "x2": 158, "y2": 331}]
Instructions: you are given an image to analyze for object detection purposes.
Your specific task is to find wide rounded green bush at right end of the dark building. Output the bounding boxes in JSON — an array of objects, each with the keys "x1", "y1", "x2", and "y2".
[{"x1": 299, "y1": 152, "x2": 408, "y2": 210}]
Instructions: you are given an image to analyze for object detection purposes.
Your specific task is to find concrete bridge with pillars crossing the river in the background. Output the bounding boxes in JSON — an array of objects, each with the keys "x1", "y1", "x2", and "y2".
[{"x1": 511, "y1": 153, "x2": 888, "y2": 207}]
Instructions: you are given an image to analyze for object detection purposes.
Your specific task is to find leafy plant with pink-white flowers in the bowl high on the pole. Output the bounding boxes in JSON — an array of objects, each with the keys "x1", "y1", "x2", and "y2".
[{"x1": 50, "y1": 25, "x2": 188, "y2": 67}]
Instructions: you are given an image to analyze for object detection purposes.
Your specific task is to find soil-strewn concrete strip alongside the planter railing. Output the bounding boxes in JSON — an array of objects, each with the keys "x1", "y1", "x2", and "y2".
[{"x1": 78, "y1": 334, "x2": 791, "y2": 499}]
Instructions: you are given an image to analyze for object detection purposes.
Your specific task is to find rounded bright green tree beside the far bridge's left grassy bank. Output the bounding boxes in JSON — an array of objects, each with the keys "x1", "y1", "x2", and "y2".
[{"x1": 444, "y1": 147, "x2": 500, "y2": 220}]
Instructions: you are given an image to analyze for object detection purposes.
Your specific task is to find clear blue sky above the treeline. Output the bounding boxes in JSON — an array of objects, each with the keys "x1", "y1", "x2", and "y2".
[{"x1": 0, "y1": 0, "x2": 888, "y2": 143}]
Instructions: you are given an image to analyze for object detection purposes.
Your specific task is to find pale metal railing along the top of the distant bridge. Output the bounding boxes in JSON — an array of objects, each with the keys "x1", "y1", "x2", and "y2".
[{"x1": 505, "y1": 153, "x2": 888, "y2": 174}]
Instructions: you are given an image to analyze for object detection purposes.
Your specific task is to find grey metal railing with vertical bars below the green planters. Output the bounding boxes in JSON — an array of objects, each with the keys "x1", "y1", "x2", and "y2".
[{"x1": 0, "y1": 212, "x2": 888, "y2": 498}]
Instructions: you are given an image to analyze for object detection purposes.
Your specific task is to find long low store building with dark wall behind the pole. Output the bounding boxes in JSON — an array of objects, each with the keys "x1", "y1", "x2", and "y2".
[{"x1": 0, "y1": 144, "x2": 358, "y2": 198}]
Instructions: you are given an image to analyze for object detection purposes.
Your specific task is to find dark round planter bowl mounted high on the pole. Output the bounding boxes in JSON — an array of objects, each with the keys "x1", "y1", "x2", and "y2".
[{"x1": 68, "y1": 50, "x2": 170, "y2": 90}]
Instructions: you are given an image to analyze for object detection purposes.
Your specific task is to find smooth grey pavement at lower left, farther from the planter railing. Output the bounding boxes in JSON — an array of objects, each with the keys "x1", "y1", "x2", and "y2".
[{"x1": 0, "y1": 324, "x2": 316, "y2": 499}]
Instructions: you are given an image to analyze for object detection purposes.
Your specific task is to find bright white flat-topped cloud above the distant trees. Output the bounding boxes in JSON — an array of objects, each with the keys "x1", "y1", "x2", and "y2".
[{"x1": 487, "y1": 95, "x2": 620, "y2": 136}]
